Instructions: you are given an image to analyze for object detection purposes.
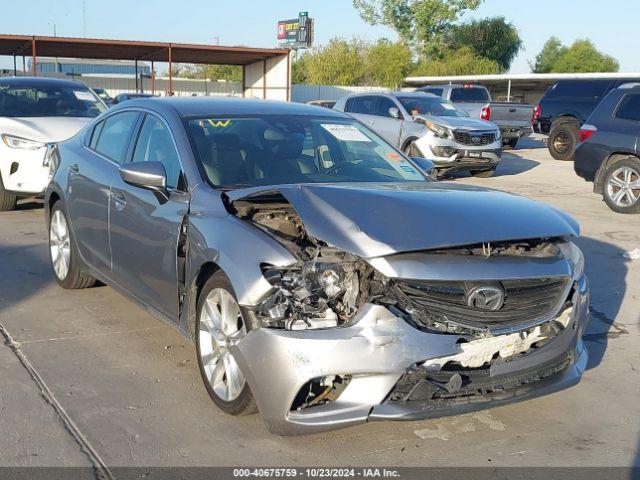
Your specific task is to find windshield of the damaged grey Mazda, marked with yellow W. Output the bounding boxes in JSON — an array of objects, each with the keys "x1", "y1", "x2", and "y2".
[{"x1": 187, "y1": 115, "x2": 426, "y2": 189}]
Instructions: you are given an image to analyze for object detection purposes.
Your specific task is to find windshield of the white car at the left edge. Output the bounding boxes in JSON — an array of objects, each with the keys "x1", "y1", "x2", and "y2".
[{"x1": 0, "y1": 85, "x2": 106, "y2": 117}]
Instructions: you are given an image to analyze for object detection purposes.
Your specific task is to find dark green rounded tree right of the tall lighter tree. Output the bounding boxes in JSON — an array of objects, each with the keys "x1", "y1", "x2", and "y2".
[{"x1": 446, "y1": 17, "x2": 522, "y2": 72}]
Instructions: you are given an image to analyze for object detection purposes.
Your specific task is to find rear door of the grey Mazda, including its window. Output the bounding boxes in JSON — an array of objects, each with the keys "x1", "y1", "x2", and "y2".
[{"x1": 67, "y1": 111, "x2": 139, "y2": 276}]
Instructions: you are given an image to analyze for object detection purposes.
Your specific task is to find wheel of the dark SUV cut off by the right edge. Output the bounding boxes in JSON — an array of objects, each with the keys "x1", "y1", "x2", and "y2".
[{"x1": 604, "y1": 157, "x2": 640, "y2": 213}]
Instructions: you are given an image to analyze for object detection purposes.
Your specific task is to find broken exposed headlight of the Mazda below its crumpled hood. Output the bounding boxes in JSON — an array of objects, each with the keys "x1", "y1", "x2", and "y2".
[{"x1": 257, "y1": 250, "x2": 362, "y2": 330}]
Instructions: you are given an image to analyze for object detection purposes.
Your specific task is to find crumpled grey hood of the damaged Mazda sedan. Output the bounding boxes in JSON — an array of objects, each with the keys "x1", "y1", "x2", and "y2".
[{"x1": 227, "y1": 182, "x2": 579, "y2": 258}]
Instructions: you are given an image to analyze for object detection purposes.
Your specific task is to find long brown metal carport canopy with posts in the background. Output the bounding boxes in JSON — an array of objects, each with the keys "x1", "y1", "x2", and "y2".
[{"x1": 0, "y1": 35, "x2": 291, "y2": 99}]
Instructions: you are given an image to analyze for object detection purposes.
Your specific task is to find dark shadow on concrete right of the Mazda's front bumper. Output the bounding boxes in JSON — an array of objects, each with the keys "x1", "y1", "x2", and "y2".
[{"x1": 576, "y1": 237, "x2": 630, "y2": 370}]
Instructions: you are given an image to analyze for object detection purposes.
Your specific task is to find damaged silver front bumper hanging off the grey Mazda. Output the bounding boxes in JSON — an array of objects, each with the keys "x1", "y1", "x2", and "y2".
[{"x1": 233, "y1": 276, "x2": 588, "y2": 435}]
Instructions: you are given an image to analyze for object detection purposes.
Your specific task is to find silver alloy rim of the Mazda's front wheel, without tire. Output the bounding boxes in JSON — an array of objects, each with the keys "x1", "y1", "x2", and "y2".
[{"x1": 198, "y1": 288, "x2": 247, "y2": 402}]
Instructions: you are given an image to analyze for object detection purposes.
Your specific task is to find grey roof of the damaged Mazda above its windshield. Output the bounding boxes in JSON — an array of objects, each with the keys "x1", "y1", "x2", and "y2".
[{"x1": 123, "y1": 97, "x2": 350, "y2": 118}]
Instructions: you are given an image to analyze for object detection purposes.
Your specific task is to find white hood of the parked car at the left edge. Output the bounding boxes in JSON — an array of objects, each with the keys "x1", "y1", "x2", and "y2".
[{"x1": 0, "y1": 117, "x2": 93, "y2": 143}]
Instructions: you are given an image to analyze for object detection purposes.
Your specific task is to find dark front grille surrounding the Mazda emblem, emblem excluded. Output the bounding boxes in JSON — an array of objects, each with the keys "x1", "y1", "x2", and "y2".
[{"x1": 396, "y1": 277, "x2": 568, "y2": 330}]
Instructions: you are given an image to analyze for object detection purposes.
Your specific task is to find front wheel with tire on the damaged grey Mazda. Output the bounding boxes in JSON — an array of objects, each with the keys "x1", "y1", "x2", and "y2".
[{"x1": 196, "y1": 271, "x2": 257, "y2": 415}]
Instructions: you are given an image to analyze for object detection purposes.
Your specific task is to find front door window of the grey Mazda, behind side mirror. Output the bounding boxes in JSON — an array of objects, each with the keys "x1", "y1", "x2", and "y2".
[{"x1": 133, "y1": 115, "x2": 181, "y2": 189}]
